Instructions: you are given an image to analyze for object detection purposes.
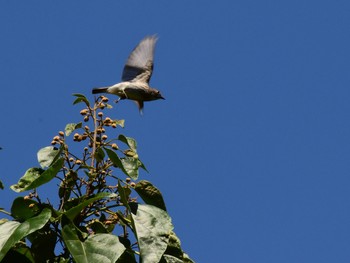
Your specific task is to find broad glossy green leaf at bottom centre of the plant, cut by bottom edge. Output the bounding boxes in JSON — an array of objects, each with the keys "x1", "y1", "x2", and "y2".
[{"x1": 62, "y1": 219, "x2": 125, "y2": 263}]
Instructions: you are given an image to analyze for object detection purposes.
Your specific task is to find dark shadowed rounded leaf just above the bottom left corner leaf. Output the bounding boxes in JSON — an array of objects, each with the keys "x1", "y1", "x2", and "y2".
[{"x1": 11, "y1": 197, "x2": 39, "y2": 222}]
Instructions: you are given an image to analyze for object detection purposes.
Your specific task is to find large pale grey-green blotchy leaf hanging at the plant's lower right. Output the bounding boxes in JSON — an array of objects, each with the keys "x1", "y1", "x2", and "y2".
[{"x1": 129, "y1": 203, "x2": 173, "y2": 262}]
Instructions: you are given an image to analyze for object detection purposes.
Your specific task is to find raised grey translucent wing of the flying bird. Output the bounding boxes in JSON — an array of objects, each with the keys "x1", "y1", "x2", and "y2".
[{"x1": 122, "y1": 36, "x2": 157, "y2": 83}]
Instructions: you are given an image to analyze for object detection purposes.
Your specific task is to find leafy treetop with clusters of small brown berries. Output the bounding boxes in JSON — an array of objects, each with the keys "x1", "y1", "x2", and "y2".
[{"x1": 0, "y1": 94, "x2": 193, "y2": 263}]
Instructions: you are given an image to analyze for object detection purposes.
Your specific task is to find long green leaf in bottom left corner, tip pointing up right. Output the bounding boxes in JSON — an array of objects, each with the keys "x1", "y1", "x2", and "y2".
[{"x1": 0, "y1": 208, "x2": 51, "y2": 261}]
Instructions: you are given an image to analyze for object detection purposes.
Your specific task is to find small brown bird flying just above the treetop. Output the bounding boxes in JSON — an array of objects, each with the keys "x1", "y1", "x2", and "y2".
[{"x1": 92, "y1": 36, "x2": 164, "y2": 113}]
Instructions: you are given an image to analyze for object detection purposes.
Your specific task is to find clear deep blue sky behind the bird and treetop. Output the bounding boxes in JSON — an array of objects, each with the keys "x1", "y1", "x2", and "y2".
[{"x1": 0, "y1": 0, "x2": 350, "y2": 263}]
